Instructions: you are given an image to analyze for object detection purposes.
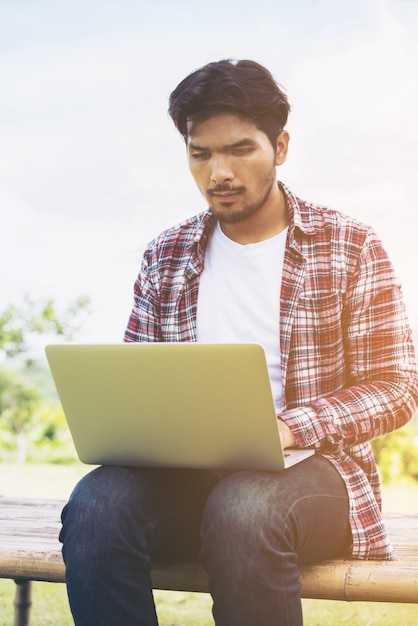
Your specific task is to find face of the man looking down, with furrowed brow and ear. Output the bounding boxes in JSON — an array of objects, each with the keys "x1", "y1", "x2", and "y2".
[{"x1": 187, "y1": 113, "x2": 288, "y2": 224}]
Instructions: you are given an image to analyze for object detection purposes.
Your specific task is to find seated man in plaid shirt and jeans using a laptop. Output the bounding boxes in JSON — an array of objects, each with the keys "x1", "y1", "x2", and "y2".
[{"x1": 61, "y1": 61, "x2": 418, "y2": 626}]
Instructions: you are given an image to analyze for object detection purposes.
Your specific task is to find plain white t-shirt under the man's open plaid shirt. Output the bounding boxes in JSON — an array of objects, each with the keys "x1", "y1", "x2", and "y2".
[{"x1": 196, "y1": 223, "x2": 287, "y2": 413}]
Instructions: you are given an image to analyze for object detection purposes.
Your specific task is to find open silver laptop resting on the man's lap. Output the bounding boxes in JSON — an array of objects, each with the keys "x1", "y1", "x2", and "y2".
[{"x1": 46, "y1": 343, "x2": 313, "y2": 471}]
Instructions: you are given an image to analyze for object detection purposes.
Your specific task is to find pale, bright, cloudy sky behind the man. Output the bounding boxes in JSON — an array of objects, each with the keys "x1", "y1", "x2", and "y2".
[{"x1": 0, "y1": 0, "x2": 418, "y2": 342}]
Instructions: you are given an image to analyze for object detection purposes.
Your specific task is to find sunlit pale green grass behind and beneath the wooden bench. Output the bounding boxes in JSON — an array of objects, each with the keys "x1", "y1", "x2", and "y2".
[{"x1": 0, "y1": 464, "x2": 418, "y2": 626}]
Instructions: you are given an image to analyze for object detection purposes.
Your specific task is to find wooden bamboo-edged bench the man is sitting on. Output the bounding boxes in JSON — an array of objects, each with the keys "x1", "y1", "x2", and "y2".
[{"x1": 0, "y1": 497, "x2": 418, "y2": 626}]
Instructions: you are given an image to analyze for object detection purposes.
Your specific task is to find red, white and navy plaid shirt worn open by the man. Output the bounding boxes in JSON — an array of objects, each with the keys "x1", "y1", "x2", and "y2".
[{"x1": 125, "y1": 183, "x2": 418, "y2": 559}]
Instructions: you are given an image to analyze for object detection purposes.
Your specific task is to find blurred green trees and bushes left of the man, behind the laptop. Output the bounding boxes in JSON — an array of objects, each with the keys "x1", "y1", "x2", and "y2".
[{"x1": 0, "y1": 296, "x2": 89, "y2": 462}]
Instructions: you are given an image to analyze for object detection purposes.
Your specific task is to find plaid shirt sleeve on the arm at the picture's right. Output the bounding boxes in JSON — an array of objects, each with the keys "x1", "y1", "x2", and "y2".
[{"x1": 280, "y1": 233, "x2": 418, "y2": 452}]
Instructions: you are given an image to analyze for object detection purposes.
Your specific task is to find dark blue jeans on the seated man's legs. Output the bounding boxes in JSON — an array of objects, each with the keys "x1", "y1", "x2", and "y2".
[{"x1": 60, "y1": 456, "x2": 351, "y2": 626}]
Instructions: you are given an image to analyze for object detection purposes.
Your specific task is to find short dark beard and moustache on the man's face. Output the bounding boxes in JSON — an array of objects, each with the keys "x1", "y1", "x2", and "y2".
[{"x1": 208, "y1": 168, "x2": 277, "y2": 224}]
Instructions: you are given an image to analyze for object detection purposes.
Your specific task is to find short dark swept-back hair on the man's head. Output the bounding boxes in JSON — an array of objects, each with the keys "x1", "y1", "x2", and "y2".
[{"x1": 168, "y1": 59, "x2": 290, "y2": 147}]
